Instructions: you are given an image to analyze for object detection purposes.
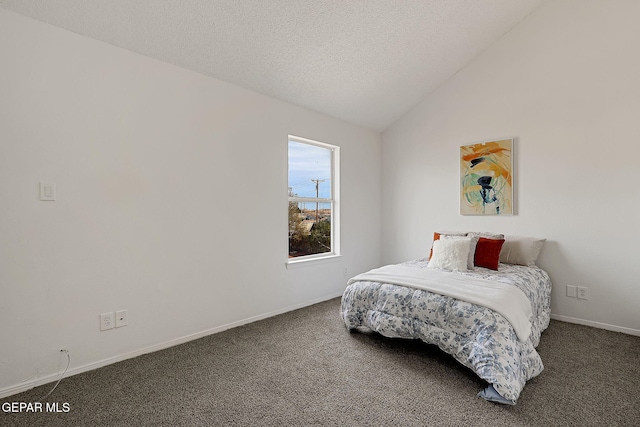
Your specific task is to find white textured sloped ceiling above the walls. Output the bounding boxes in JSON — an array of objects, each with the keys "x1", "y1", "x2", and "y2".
[{"x1": 0, "y1": 0, "x2": 546, "y2": 131}]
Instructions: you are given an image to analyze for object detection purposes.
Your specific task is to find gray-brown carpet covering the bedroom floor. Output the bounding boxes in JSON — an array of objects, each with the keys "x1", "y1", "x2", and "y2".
[{"x1": 0, "y1": 299, "x2": 640, "y2": 426}]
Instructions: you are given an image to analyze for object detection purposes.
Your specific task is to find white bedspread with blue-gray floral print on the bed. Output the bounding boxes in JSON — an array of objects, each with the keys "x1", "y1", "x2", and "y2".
[{"x1": 341, "y1": 260, "x2": 551, "y2": 402}]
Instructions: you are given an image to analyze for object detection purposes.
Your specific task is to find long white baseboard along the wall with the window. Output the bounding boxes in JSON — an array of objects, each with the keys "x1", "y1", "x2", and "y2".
[{"x1": 0, "y1": 292, "x2": 342, "y2": 399}]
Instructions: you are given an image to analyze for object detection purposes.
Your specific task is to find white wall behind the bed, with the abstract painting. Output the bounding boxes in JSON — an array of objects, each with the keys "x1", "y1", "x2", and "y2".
[{"x1": 383, "y1": 0, "x2": 640, "y2": 334}]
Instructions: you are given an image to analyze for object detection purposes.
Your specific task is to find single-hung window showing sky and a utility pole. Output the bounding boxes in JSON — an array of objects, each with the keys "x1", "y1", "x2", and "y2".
[{"x1": 289, "y1": 136, "x2": 340, "y2": 260}]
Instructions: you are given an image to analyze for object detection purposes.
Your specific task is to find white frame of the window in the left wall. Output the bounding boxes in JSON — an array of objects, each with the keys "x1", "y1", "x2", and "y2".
[{"x1": 286, "y1": 135, "x2": 340, "y2": 268}]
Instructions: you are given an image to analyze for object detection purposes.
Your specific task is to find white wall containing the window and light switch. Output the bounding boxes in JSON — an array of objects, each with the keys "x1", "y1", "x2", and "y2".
[{"x1": 0, "y1": 9, "x2": 381, "y2": 396}]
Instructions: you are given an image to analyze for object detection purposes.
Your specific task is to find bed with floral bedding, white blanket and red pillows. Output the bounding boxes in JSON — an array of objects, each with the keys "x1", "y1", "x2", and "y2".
[{"x1": 341, "y1": 233, "x2": 551, "y2": 405}]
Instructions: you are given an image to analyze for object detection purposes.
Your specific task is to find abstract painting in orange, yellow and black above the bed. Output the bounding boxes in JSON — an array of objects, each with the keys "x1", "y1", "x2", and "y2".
[{"x1": 460, "y1": 139, "x2": 513, "y2": 215}]
